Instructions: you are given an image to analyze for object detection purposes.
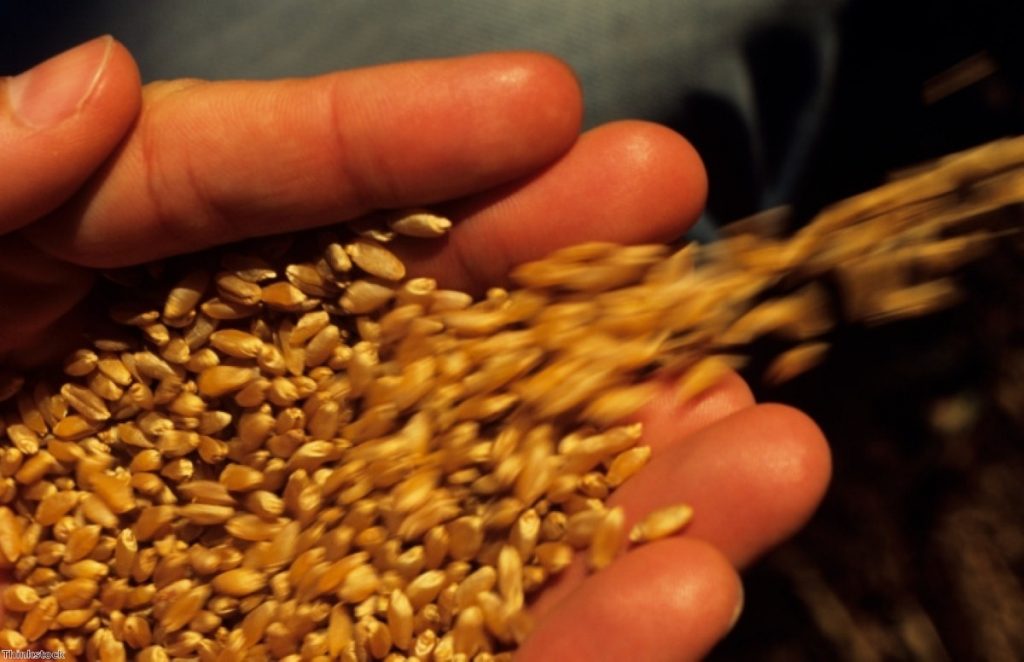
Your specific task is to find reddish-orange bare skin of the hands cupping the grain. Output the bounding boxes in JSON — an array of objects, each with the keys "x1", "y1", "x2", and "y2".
[{"x1": 0, "y1": 40, "x2": 830, "y2": 660}]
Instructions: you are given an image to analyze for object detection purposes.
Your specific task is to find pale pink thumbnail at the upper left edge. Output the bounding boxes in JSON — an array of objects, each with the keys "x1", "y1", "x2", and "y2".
[{"x1": 7, "y1": 35, "x2": 114, "y2": 129}]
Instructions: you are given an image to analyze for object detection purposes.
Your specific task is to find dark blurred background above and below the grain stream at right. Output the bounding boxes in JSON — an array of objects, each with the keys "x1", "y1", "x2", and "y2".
[{"x1": 705, "y1": 0, "x2": 1024, "y2": 661}]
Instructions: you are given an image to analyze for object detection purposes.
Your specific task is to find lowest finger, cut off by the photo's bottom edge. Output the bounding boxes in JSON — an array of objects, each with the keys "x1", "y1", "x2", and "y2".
[{"x1": 518, "y1": 539, "x2": 742, "y2": 662}]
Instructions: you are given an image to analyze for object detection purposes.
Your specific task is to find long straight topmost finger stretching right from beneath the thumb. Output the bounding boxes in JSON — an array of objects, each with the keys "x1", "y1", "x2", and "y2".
[{"x1": 25, "y1": 53, "x2": 581, "y2": 266}]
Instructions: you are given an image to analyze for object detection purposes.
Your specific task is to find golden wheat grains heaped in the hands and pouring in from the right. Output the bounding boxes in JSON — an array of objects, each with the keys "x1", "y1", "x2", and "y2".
[{"x1": 0, "y1": 137, "x2": 1016, "y2": 661}]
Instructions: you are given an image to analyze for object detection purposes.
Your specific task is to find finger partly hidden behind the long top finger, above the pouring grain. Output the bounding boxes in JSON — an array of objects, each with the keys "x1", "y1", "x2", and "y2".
[{"x1": 402, "y1": 121, "x2": 707, "y2": 291}]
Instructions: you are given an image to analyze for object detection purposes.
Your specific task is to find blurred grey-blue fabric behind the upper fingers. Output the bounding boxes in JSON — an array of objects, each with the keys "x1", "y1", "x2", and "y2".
[{"x1": 0, "y1": 0, "x2": 844, "y2": 237}]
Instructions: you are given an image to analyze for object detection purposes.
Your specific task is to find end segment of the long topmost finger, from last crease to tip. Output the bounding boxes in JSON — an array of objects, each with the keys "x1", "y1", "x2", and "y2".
[{"x1": 331, "y1": 51, "x2": 583, "y2": 213}]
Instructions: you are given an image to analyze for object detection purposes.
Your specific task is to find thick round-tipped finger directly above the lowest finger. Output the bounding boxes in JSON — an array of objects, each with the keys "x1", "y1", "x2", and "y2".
[{"x1": 609, "y1": 405, "x2": 831, "y2": 568}]
